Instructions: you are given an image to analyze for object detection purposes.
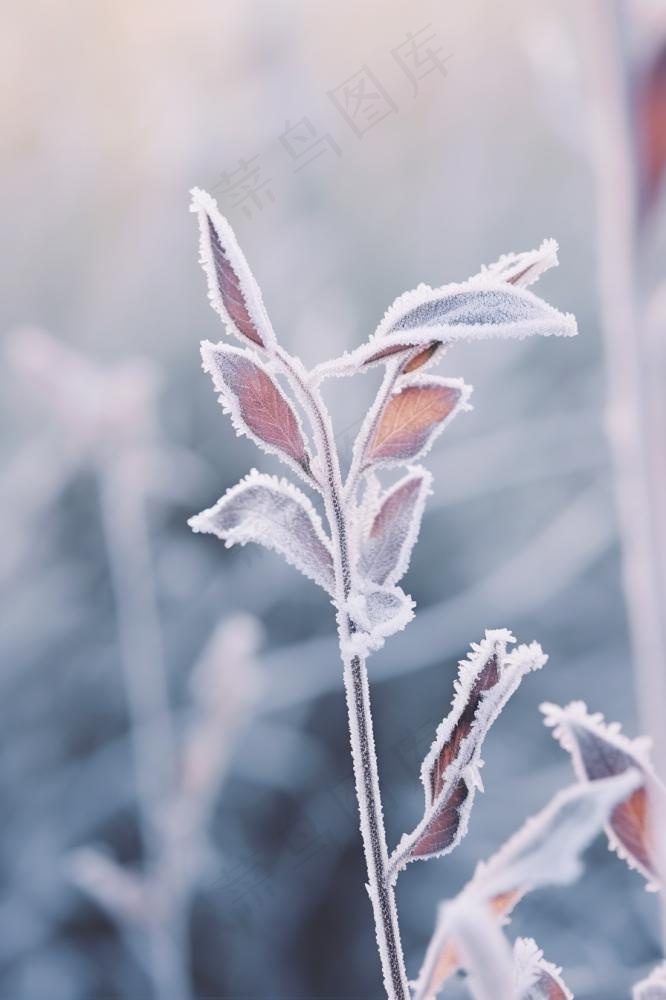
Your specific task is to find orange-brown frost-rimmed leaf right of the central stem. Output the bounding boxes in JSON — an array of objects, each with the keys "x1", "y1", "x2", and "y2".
[{"x1": 363, "y1": 375, "x2": 471, "y2": 468}]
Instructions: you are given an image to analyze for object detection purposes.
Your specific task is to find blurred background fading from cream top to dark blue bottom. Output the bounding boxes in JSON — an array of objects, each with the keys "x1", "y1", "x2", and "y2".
[{"x1": 0, "y1": 0, "x2": 659, "y2": 1000}]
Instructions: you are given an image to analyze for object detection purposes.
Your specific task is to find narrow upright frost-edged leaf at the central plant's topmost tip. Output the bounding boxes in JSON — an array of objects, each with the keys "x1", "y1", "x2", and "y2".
[{"x1": 190, "y1": 188, "x2": 275, "y2": 347}]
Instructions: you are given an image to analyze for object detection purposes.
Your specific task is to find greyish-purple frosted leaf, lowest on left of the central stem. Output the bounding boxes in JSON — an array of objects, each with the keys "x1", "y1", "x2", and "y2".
[{"x1": 188, "y1": 470, "x2": 335, "y2": 593}]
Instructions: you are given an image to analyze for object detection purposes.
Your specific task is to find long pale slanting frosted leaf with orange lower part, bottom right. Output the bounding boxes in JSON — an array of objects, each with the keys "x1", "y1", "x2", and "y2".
[{"x1": 414, "y1": 769, "x2": 641, "y2": 1000}]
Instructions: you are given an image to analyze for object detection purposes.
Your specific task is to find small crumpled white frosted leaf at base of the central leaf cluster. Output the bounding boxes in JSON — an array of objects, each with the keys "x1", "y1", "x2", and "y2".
[{"x1": 346, "y1": 585, "x2": 414, "y2": 656}]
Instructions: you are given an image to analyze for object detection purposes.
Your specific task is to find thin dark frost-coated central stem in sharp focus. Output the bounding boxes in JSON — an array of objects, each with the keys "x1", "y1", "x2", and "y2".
[{"x1": 277, "y1": 349, "x2": 410, "y2": 1000}]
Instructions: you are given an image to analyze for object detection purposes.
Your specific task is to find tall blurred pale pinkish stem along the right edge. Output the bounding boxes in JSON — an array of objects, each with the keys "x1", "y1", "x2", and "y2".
[{"x1": 587, "y1": 0, "x2": 666, "y2": 951}]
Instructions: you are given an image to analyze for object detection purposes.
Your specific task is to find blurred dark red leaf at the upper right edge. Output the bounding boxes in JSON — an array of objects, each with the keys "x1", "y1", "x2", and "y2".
[{"x1": 635, "y1": 45, "x2": 666, "y2": 216}]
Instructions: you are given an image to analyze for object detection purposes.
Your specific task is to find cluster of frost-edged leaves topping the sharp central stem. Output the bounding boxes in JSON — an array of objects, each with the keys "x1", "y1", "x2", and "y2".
[{"x1": 190, "y1": 189, "x2": 575, "y2": 655}]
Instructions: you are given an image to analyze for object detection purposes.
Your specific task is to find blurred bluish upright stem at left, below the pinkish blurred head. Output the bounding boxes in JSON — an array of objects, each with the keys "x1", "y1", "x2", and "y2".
[{"x1": 100, "y1": 458, "x2": 191, "y2": 1000}]
